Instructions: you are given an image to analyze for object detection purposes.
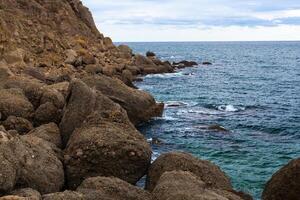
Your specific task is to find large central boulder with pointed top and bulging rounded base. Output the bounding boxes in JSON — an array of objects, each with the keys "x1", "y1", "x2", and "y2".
[{"x1": 60, "y1": 80, "x2": 151, "y2": 188}]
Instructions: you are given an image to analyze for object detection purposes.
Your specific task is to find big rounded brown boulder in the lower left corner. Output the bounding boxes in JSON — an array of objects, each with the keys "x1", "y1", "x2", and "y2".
[{"x1": 0, "y1": 131, "x2": 64, "y2": 194}]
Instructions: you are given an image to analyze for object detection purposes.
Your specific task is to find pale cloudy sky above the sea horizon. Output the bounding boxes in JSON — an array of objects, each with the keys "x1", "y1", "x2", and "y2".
[{"x1": 82, "y1": 0, "x2": 300, "y2": 42}]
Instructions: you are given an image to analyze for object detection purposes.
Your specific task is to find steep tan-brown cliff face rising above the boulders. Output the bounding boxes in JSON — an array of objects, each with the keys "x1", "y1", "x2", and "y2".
[{"x1": 0, "y1": 0, "x2": 118, "y2": 71}]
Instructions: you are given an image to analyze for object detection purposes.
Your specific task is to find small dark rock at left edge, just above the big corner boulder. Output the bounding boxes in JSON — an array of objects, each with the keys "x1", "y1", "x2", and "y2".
[{"x1": 2, "y1": 116, "x2": 33, "y2": 134}]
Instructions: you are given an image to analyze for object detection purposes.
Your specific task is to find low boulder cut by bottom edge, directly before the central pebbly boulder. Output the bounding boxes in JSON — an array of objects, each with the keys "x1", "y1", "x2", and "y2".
[{"x1": 77, "y1": 177, "x2": 152, "y2": 200}]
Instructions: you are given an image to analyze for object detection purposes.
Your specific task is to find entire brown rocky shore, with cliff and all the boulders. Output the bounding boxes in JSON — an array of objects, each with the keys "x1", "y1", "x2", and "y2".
[{"x1": 0, "y1": 0, "x2": 300, "y2": 200}]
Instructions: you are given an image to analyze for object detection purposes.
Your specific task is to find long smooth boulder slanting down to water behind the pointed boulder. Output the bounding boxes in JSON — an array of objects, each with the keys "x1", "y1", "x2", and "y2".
[{"x1": 83, "y1": 75, "x2": 164, "y2": 125}]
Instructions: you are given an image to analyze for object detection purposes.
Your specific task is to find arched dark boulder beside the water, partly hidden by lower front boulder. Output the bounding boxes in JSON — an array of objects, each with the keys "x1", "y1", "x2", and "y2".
[{"x1": 146, "y1": 152, "x2": 232, "y2": 191}]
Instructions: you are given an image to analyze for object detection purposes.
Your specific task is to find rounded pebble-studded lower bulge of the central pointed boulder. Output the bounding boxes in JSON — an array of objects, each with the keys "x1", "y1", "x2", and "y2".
[{"x1": 65, "y1": 119, "x2": 151, "y2": 188}]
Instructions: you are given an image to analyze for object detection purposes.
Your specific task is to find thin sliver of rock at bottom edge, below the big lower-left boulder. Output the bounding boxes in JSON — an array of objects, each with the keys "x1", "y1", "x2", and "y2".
[{"x1": 43, "y1": 191, "x2": 86, "y2": 200}]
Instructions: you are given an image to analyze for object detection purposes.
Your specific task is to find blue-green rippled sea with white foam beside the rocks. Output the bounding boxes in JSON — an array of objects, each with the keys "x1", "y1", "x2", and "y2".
[{"x1": 118, "y1": 42, "x2": 300, "y2": 199}]
